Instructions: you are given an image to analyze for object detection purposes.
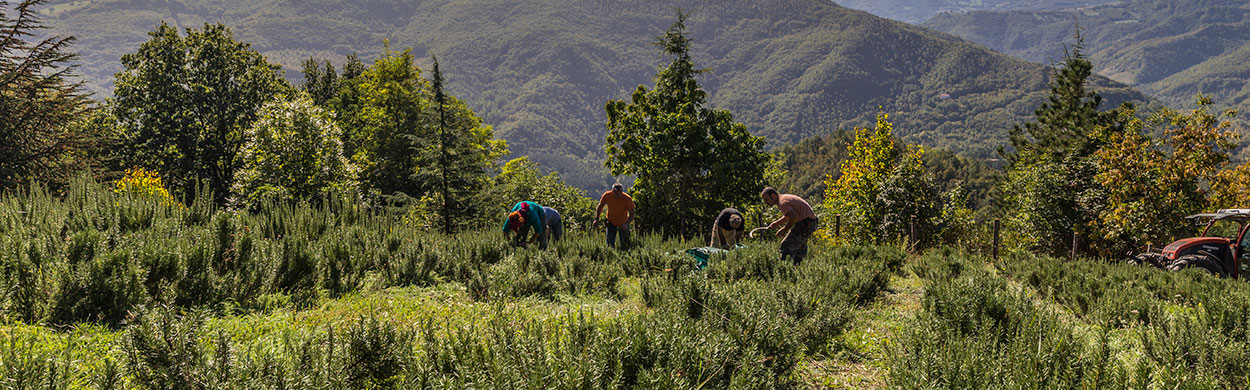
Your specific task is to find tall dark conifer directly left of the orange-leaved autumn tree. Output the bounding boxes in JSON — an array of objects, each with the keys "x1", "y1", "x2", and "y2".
[{"x1": 999, "y1": 31, "x2": 1123, "y2": 255}]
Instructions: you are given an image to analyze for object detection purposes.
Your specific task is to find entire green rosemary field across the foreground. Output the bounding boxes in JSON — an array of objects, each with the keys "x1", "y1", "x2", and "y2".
[{"x1": 0, "y1": 181, "x2": 1250, "y2": 389}]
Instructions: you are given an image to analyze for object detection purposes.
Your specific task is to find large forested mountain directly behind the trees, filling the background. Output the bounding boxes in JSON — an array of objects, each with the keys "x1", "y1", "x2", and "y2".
[{"x1": 46, "y1": 0, "x2": 1145, "y2": 189}]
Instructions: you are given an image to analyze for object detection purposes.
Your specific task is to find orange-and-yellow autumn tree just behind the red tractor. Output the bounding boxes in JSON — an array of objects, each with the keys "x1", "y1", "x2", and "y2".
[{"x1": 1094, "y1": 98, "x2": 1245, "y2": 256}]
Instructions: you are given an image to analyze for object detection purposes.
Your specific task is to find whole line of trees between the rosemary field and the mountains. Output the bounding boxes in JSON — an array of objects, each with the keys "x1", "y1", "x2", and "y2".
[{"x1": 0, "y1": 0, "x2": 1250, "y2": 256}]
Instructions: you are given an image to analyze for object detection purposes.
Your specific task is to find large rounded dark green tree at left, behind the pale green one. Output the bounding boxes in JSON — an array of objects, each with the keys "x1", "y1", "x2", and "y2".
[{"x1": 113, "y1": 23, "x2": 291, "y2": 203}]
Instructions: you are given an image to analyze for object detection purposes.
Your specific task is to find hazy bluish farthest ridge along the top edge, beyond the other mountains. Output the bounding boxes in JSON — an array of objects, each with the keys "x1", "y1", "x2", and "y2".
[{"x1": 834, "y1": 0, "x2": 1114, "y2": 24}]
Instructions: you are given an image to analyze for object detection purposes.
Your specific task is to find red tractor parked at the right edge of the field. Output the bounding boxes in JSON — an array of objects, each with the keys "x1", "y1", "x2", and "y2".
[{"x1": 1129, "y1": 209, "x2": 1250, "y2": 279}]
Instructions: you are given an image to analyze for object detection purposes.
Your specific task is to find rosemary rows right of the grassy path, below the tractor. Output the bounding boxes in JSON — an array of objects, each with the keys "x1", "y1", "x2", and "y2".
[{"x1": 890, "y1": 251, "x2": 1250, "y2": 389}]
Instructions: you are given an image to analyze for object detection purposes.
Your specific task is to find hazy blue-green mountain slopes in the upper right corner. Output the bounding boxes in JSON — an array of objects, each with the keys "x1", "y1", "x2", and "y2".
[{"x1": 926, "y1": 0, "x2": 1250, "y2": 111}]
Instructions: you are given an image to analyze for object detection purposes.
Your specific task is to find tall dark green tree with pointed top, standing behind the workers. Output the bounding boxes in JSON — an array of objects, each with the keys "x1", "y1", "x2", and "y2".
[{"x1": 604, "y1": 10, "x2": 770, "y2": 236}]
